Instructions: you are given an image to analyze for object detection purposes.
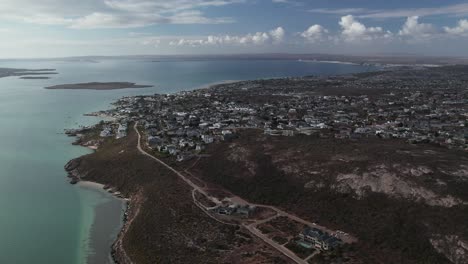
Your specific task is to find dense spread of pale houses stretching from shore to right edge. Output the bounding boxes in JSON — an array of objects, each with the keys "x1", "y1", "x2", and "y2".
[{"x1": 94, "y1": 70, "x2": 468, "y2": 158}]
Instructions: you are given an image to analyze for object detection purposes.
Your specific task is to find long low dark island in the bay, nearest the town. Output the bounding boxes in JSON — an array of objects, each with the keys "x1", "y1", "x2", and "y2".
[{"x1": 45, "y1": 82, "x2": 153, "y2": 90}]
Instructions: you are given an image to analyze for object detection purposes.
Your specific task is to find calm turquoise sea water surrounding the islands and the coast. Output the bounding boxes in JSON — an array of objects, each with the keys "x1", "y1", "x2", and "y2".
[{"x1": 0, "y1": 60, "x2": 374, "y2": 264}]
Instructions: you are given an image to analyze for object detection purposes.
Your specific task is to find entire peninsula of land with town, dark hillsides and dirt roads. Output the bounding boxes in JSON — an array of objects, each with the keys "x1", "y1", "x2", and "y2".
[{"x1": 66, "y1": 66, "x2": 468, "y2": 264}]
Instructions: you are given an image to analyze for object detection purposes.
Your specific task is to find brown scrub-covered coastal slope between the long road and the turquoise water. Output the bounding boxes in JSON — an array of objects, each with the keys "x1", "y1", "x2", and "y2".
[{"x1": 67, "y1": 127, "x2": 290, "y2": 264}]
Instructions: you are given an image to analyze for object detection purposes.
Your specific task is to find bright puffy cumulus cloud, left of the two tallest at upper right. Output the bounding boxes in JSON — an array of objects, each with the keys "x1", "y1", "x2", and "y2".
[{"x1": 339, "y1": 15, "x2": 391, "y2": 42}]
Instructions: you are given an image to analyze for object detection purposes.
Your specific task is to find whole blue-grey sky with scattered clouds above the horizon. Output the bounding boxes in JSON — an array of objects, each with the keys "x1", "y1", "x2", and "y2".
[{"x1": 0, "y1": 0, "x2": 468, "y2": 58}]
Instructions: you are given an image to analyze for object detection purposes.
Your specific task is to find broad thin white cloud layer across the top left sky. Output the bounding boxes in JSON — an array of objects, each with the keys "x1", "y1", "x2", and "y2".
[{"x1": 0, "y1": 0, "x2": 241, "y2": 28}]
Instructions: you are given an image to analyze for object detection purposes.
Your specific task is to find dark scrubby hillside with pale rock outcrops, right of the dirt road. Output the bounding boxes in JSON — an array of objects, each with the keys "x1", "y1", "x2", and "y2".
[{"x1": 191, "y1": 131, "x2": 468, "y2": 263}]
